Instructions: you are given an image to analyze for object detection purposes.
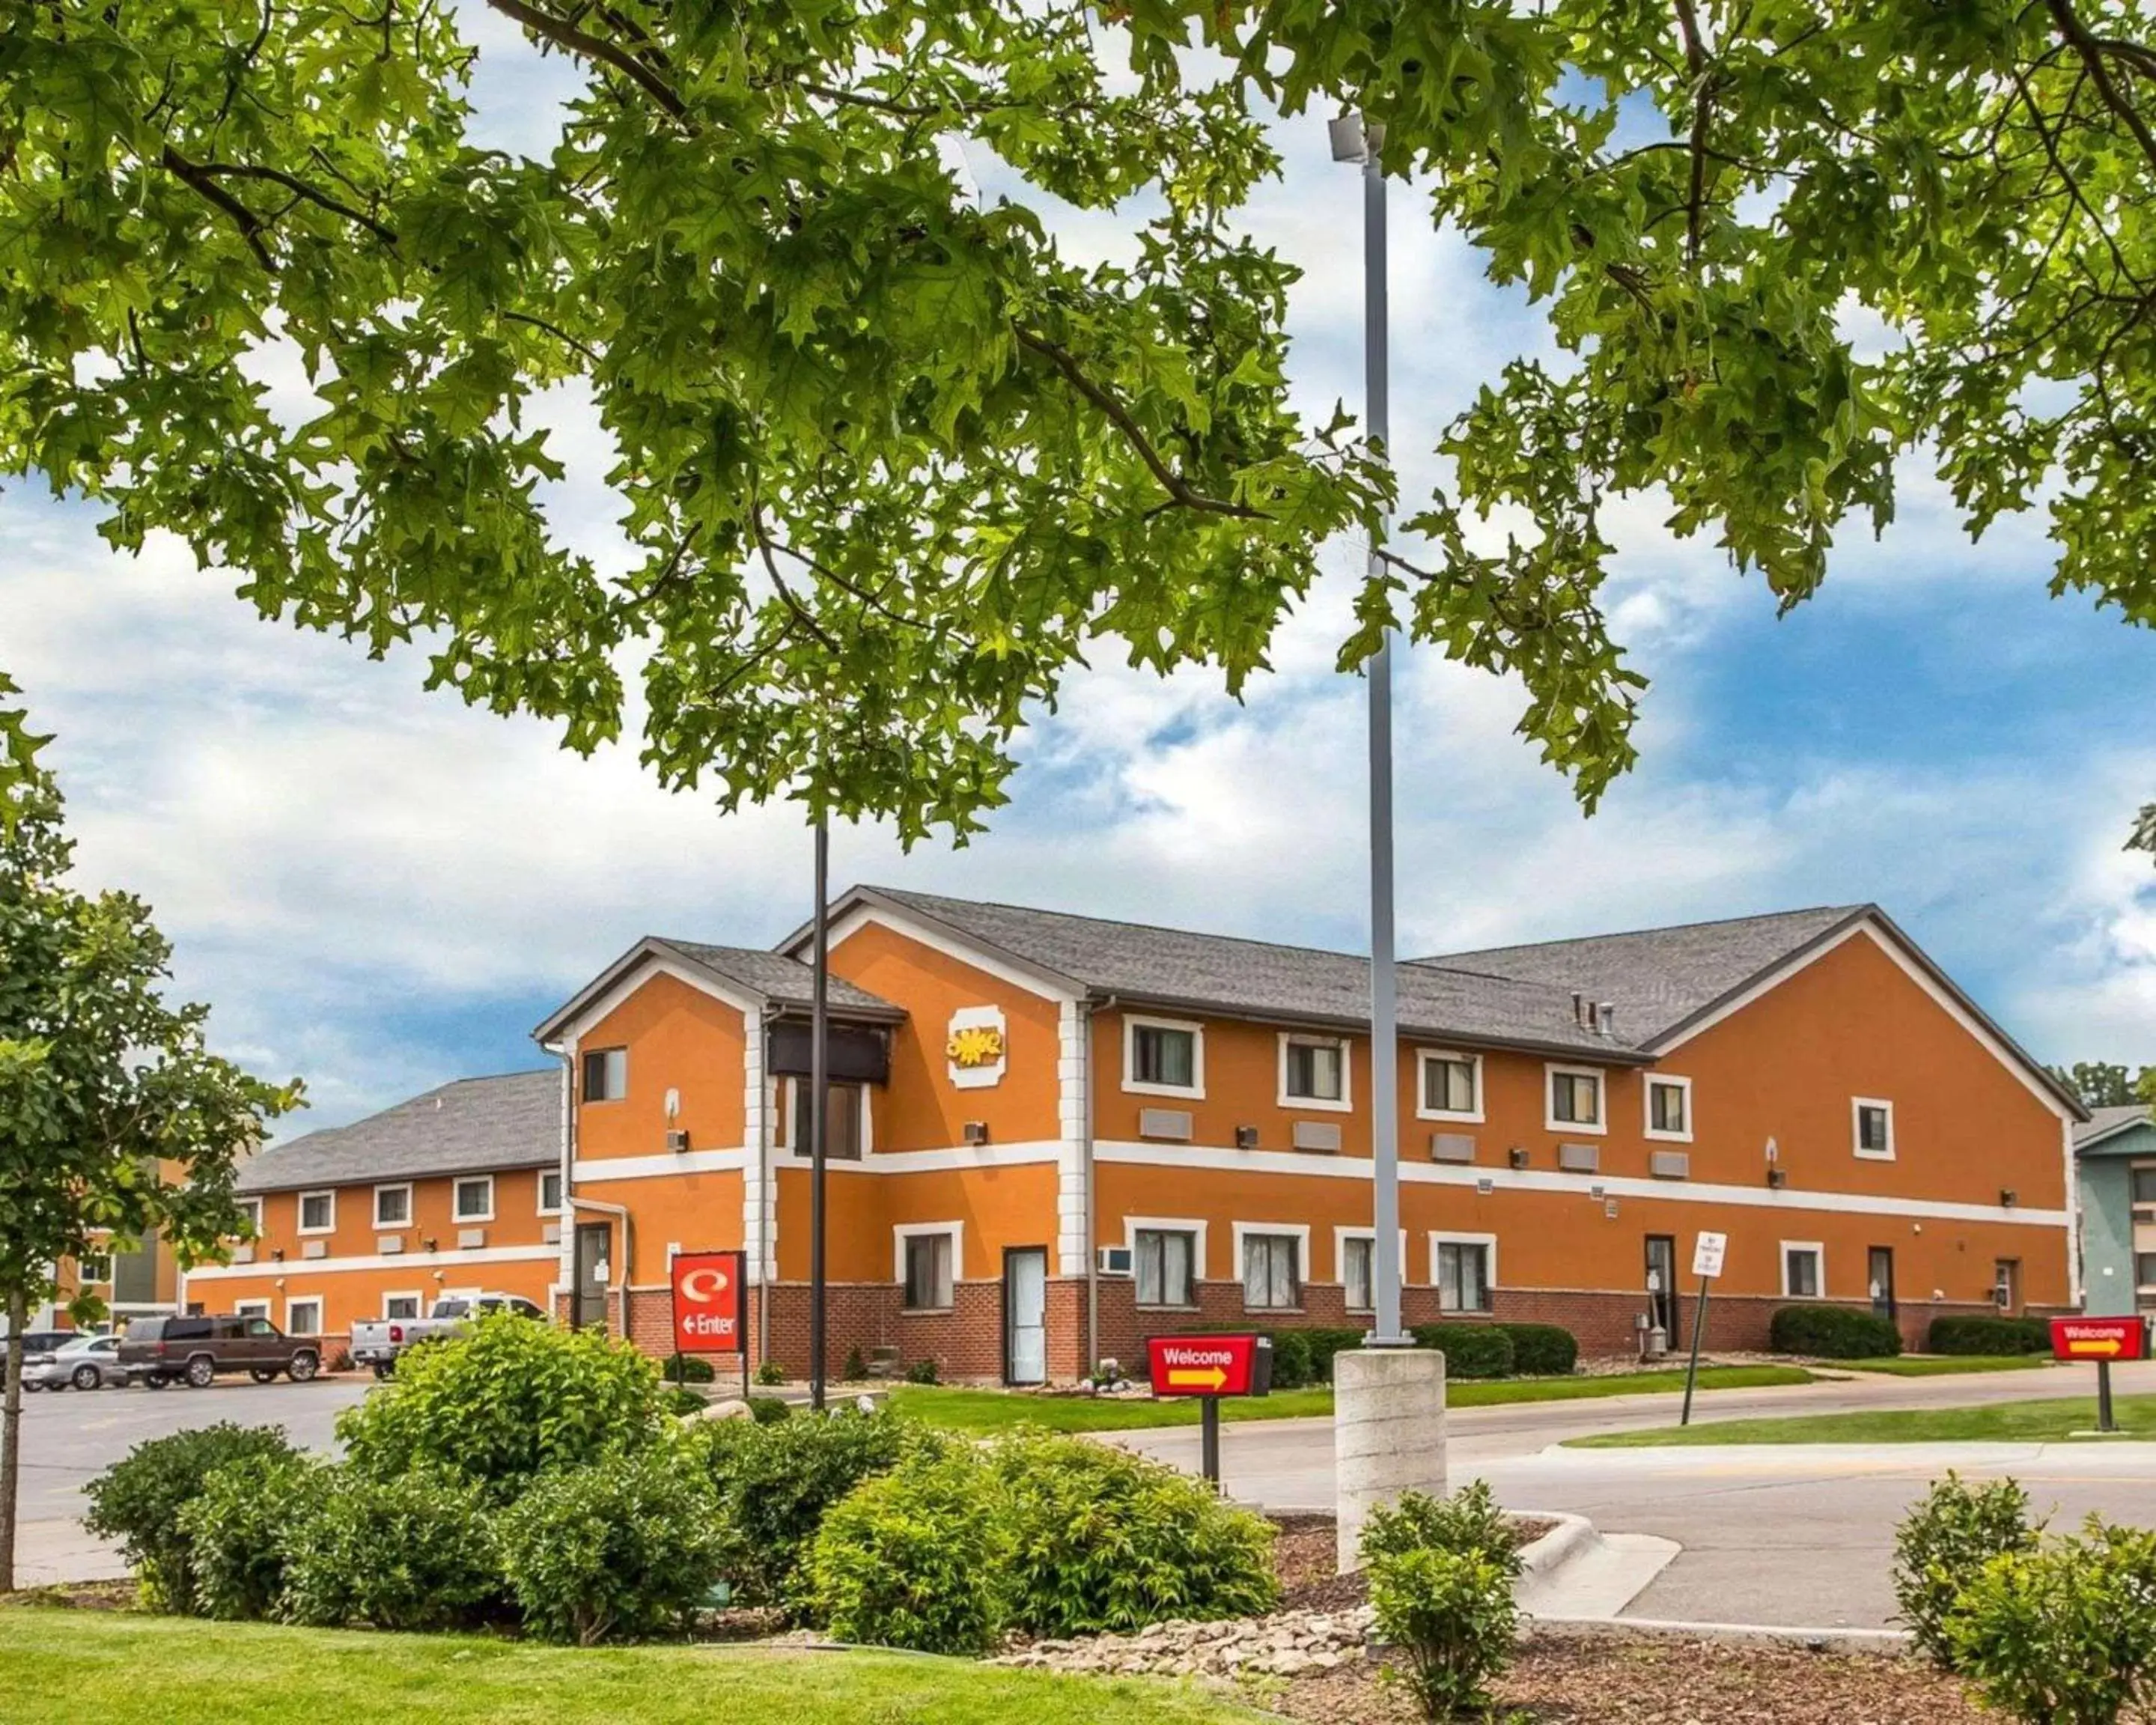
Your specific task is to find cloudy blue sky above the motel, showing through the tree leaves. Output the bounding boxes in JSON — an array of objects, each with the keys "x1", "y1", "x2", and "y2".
[{"x1": 0, "y1": 22, "x2": 2156, "y2": 1130}]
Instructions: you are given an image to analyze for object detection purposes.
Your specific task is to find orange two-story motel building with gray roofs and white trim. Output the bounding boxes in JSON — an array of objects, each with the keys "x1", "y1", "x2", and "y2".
[{"x1": 183, "y1": 886, "x2": 2085, "y2": 1382}]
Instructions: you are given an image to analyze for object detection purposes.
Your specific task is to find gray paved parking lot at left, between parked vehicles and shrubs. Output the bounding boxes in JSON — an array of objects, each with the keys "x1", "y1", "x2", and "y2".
[{"x1": 17, "y1": 1375, "x2": 373, "y2": 1587}]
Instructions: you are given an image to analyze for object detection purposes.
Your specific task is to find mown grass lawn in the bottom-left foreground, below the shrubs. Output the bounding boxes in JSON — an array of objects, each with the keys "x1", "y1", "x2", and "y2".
[{"x1": 0, "y1": 1608, "x2": 1259, "y2": 1725}]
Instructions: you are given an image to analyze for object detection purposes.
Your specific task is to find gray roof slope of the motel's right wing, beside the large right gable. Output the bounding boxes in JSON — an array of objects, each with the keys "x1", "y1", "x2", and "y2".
[{"x1": 1414, "y1": 906, "x2": 1872, "y2": 1044}]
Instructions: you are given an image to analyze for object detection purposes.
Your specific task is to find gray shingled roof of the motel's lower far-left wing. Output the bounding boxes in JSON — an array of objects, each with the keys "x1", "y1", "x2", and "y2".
[{"x1": 240, "y1": 1068, "x2": 561, "y2": 1193}]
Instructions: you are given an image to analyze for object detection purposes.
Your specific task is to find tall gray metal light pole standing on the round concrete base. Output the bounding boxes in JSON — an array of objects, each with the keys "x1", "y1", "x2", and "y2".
[{"x1": 1330, "y1": 115, "x2": 1410, "y2": 1348}]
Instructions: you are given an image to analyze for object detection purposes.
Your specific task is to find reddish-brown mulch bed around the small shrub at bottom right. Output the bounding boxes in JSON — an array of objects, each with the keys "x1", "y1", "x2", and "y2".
[{"x1": 1259, "y1": 1639, "x2": 1997, "y2": 1725}]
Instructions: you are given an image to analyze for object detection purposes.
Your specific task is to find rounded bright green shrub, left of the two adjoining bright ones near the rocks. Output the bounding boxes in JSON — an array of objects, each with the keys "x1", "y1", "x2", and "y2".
[{"x1": 806, "y1": 1428, "x2": 1011, "y2": 1654}]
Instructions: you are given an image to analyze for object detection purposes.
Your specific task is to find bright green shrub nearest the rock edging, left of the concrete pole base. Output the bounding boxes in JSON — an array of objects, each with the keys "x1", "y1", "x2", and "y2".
[{"x1": 990, "y1": 1429, "x2": 1281, "y2": 1637}]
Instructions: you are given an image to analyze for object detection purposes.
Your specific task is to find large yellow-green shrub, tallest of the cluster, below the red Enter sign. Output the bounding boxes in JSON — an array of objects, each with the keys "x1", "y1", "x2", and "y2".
[{"x1": 336, "y1": 1315, "x2": 664, "y2": 1503}]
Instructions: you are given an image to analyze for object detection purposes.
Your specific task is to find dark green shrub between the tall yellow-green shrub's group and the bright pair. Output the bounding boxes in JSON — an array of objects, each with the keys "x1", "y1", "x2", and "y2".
[{"x1": 694, "y1": 1411, "x2": 922, "y2": 1604}]
